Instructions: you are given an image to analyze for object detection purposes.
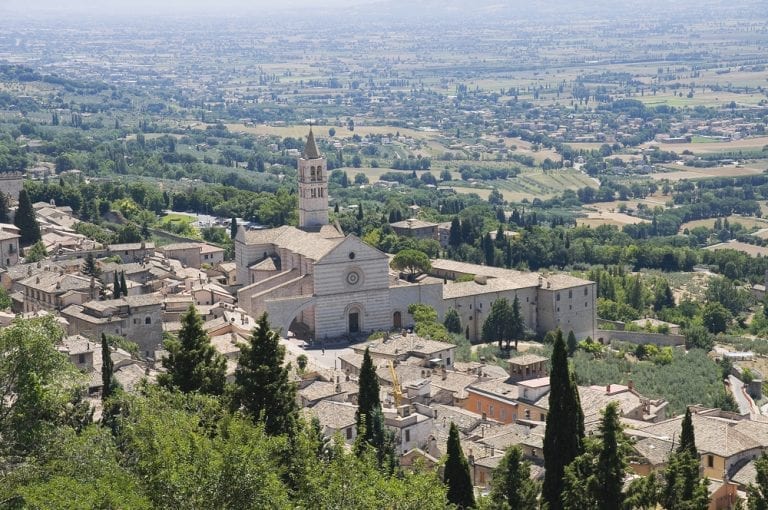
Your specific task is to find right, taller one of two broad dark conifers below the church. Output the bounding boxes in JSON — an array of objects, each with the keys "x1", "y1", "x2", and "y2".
[{"x1": 232, "y1": 312, "x2": 298, "y2": 435}]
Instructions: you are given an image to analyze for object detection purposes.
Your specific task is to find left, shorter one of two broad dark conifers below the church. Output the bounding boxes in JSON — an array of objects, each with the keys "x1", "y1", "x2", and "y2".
[{"x1": 158, "y1": 305, "x2": 227, "y2": 395}]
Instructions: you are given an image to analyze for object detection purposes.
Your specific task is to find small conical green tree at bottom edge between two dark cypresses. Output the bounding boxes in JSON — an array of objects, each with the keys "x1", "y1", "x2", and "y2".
[{"x1": 490, "y1": 446, "x2": 539, "y2": 510}]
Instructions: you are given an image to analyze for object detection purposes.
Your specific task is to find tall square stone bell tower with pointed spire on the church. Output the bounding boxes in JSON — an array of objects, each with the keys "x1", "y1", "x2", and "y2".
[{"x1": 299, "y1": 126, "x2": 328, "y2": 230}]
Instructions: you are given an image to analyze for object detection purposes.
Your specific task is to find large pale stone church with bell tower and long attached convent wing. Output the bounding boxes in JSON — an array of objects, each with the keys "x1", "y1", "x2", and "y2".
[{"x1": 235, "y1": 128, "x2": 596, "y2": 340}]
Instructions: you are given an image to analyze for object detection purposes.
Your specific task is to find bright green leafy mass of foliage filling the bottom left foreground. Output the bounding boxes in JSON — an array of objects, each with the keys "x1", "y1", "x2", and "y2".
[{"x1": 0, "y1": 387, "x2": 447, "y2": 510}]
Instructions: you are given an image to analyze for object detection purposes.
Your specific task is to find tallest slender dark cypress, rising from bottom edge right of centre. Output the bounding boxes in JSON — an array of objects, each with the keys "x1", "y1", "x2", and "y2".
[{"x1": 542, "y1": 329, "x2": 584, "y2": 510}]
